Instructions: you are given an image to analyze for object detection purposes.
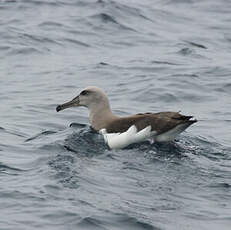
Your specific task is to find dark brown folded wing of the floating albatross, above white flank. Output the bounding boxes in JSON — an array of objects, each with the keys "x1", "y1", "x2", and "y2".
[{"x1": 106, "y1": 112, "x2": 196, "y2": 134}]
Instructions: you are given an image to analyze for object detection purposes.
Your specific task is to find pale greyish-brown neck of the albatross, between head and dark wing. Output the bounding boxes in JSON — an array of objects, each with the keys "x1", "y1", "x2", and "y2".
[{"x1": 89, "y1": 103, "x2": 118, "y2": 131}]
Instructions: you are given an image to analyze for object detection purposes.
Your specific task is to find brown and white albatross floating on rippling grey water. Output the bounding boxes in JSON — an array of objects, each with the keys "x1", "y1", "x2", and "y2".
[{"x1": 56, "y1": 86, "x2": 197, "y2": 149}]
